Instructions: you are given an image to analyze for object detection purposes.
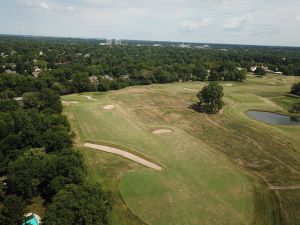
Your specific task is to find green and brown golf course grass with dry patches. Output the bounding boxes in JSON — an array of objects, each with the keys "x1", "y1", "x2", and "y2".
[{"x1": 63, "y1": 76, "x2": 300, "y2": 225}]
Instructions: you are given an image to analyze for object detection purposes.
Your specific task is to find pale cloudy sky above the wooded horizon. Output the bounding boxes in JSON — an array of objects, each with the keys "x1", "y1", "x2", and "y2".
[{"x1": 0, "y1": 0, "x2": 300, "y2": 46}]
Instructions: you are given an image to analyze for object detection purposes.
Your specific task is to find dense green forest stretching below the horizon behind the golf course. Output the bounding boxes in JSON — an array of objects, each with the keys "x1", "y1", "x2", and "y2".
[{"x1": 0, "y1": 37, "x2": 300, "y2": 95}]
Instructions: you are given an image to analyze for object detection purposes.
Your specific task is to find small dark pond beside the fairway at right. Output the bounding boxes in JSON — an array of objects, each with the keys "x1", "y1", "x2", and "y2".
[{"x1": 247, "y1": 111, "x2": 300, "y2": 126}]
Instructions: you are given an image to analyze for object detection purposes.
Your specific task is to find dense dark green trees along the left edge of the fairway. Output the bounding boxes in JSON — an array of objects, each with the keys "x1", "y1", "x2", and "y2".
[{"x1": 0, "y1": 86, "x2": 112, "y2": 225}]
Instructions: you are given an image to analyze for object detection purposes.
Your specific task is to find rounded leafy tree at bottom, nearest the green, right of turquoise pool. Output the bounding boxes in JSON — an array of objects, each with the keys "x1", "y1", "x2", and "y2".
[{"x1": 43, "y1": 184, "x2": 112, "y2": 225}]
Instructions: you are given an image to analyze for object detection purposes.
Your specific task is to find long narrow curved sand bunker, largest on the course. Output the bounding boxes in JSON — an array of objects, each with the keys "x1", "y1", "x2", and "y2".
[{"x1": 84, "y1": 143, "x2": 162, "y2": 170}]
